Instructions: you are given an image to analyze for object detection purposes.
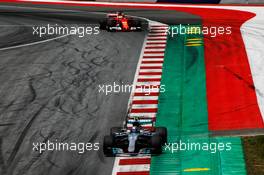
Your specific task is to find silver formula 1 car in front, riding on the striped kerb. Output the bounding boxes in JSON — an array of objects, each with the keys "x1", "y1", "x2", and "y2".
[{"x1": 103, "y1": 117, "x2": 167, "y2": 156}]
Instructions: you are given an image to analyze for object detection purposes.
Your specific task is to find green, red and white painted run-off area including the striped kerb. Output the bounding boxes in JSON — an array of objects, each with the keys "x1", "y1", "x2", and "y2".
[{"x1": 1, "y1": 0, "x2": 264, "y2": 175}]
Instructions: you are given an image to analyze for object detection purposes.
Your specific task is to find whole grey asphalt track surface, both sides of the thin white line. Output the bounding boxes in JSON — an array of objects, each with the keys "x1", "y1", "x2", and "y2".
[{"x1": 0, "y1": 4, "x2": 200, "y2": 175}]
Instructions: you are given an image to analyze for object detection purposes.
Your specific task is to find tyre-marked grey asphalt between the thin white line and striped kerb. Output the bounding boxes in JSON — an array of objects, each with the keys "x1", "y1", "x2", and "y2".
[{"x1": 0, "y1": 22, "x2": 145, "y2": 175}]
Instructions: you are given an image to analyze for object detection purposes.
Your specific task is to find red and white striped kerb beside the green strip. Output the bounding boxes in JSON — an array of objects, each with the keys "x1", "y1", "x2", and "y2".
[{"x1": 112, "y1": 22, "x2": 168, "y2": 175}]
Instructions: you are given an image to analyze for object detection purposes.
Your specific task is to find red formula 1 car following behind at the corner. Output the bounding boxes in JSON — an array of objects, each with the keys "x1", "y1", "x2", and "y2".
[{"x1": 100, "y1": 12, "x2": 142, "y2": 32}]
